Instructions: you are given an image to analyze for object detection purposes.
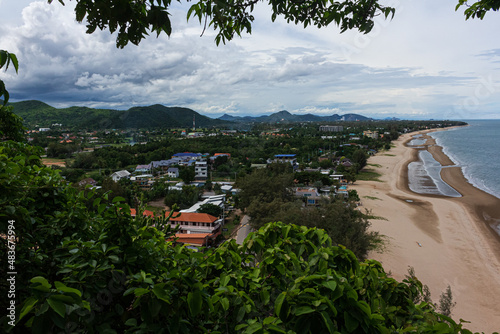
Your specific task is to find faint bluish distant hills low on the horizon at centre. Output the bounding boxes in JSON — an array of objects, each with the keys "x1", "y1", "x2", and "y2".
[{"x1": 218, "y1": 110, "x2": 371, "y2": 123}]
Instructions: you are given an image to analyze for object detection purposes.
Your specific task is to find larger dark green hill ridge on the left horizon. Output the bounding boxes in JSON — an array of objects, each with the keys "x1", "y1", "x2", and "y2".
[{"x1": 10, "y1": 101, "x2": 227, "y2": 129}]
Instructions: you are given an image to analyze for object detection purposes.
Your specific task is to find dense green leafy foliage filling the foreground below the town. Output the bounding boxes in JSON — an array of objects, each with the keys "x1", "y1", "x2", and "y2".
[{"x1": 0, "y1": 142, "x2": 486, "y2": 334}]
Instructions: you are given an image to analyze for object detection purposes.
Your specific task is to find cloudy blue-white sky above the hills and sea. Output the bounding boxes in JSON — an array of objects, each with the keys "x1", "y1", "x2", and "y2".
[{"x1": 0, "y1": 0, "x2": 500, "y2": 119}]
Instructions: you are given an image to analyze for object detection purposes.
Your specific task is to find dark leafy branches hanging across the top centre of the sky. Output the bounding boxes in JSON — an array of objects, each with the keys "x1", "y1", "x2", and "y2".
[{"x1": 48, "y1": 0, "x2": 395, "y2": 48}]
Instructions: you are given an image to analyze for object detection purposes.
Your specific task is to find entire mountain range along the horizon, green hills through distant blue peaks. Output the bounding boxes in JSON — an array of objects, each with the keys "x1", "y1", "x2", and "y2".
[{"x1": 9, "y1": 100, "x2": 371, "y2": 129}]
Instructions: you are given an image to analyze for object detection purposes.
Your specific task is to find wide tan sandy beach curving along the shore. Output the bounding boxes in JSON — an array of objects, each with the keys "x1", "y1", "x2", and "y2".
[{"x1": 352, "y1": 127, "x2": 500, "y2": 333}]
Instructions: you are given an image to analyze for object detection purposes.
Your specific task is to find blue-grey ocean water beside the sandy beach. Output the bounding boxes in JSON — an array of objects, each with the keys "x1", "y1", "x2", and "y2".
[{"x1": 430, "y1": 120, "x2": 500, "y2": 202}]
